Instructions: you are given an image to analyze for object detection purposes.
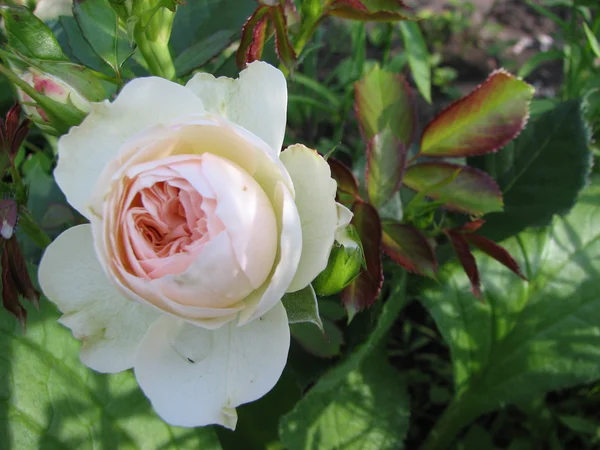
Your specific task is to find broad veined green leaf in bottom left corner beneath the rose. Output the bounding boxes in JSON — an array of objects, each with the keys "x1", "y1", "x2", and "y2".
[{"x1": 0, "y1": 299, "x2": 221, "y2": 450}]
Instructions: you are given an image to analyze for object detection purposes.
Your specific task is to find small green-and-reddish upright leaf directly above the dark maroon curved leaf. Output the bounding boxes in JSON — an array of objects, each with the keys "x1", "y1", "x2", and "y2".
[{"x1": 365, "y1": 128, "x2": 408, "y2": 208}]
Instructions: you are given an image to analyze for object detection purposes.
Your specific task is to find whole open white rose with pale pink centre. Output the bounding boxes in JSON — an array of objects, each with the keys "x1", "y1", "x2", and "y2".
[{"x1": 39, "y1": 62, "x2": 351, "y2": 429}]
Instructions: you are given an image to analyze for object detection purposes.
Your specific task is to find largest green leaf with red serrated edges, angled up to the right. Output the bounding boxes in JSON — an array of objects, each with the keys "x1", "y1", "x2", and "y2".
[{"x1": 421, "y1": 70, "x2": 534, "y2": 157}]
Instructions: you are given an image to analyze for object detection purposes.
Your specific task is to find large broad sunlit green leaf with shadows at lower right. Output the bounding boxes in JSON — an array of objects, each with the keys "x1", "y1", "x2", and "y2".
[{"x1": 422, "y1": 179, "x2": 600, "y2": 445}]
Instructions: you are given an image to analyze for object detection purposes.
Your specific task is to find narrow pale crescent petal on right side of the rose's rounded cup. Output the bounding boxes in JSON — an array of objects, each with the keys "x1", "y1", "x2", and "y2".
[{"x1": 239, "y1": 182, "x2": 302, "y2": 325}]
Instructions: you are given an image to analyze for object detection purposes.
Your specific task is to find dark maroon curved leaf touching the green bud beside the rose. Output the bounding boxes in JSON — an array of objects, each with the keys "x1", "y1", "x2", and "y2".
[{"x1": 340, "y1": 201, "x2": 383, "y2": 319}]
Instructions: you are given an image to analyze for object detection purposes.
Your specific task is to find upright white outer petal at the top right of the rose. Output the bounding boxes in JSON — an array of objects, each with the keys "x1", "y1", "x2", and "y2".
[{"x1": 186, "y1": 61, "x2": 287, "y2": 155}]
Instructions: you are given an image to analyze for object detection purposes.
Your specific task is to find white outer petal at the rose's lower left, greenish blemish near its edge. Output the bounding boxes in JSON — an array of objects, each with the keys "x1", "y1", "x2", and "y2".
[{"x1": 39, "y1": 225, "x2": 159, "y2": 373}]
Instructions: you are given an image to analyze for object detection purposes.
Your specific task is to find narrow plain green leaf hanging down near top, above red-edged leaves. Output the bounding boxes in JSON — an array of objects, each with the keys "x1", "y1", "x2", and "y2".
[{"x1": 398, "y1": 22, "x2": 431, "y2": 103}]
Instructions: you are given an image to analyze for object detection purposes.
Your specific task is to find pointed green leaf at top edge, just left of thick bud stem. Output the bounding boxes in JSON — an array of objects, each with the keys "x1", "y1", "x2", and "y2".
[{"x1": 73, "y1": 0, "x2": 133, "y2": 74}]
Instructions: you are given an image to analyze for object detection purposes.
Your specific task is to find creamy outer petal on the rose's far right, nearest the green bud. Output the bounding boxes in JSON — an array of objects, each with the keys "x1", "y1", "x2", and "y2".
[{"x1": 281, "y1": 144, "x2": 339, "y2": 292}]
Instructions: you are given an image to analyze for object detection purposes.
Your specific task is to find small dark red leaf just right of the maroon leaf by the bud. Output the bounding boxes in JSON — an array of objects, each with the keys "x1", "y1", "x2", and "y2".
[{"x1": 382, "y1": 222, "x2": 438, "y2": 279}]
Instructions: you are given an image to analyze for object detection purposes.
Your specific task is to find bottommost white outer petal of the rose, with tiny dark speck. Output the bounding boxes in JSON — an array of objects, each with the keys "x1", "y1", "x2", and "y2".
[{"x1": 135, "y1": 303, "x2": 290, "y2": 429}]
